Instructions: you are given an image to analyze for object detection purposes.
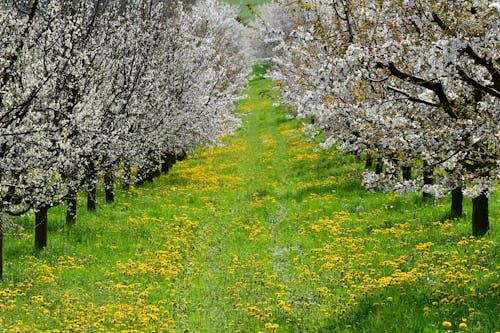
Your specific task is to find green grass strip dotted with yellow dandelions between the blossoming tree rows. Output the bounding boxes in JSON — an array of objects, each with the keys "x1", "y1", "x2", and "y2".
[{"x1": 0, "y1": 66, "x2": 500, "y2": 332}]
